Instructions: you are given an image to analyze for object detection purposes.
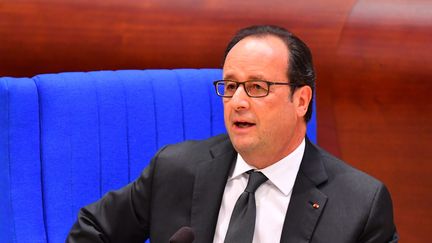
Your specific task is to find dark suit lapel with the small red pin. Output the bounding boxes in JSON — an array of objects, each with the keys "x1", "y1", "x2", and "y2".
[{"x1": 281, "y1": 139, "x2": 328, "y2": 243}]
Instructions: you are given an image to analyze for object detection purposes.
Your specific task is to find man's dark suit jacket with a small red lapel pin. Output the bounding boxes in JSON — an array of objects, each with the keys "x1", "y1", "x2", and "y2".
[{"x1": 67, "y1": 135, "x2": 397, "y2": 243}]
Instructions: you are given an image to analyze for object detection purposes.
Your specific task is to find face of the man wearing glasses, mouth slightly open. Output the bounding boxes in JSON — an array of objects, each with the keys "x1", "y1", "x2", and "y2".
[{"x1": 223, "y1": 36, "x2": 307, "y2": 166}]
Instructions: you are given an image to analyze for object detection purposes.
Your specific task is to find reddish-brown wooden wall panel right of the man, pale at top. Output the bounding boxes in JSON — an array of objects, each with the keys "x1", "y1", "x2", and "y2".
[{"x1": 332, "y1": 0, "x2": 432, "y2": 242}]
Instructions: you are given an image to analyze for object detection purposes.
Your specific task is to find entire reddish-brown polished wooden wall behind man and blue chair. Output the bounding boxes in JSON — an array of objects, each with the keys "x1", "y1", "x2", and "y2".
[{"x1": 0, "y1": 0, "x2": 432, "y2": 242}]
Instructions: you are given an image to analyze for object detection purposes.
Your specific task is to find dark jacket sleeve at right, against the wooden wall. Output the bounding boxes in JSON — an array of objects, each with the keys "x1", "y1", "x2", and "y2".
[{"x1": 360, "y1": 184, "x2": 398, "y2": 243}]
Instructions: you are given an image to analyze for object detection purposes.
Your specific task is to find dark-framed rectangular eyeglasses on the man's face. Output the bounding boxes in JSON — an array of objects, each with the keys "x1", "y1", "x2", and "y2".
[{"x1": 213, "y1": 80, "x2": 304, "y2": 98}]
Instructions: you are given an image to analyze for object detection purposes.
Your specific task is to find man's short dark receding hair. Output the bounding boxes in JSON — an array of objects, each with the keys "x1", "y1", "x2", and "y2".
[{"x1": 222, "y1": 25, "x2": 315, "y2": 122}]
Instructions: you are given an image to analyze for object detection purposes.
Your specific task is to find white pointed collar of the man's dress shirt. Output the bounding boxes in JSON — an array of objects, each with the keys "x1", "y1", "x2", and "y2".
[{"x1": 228, "y1": 139, "x2": 306, "y2": 196}]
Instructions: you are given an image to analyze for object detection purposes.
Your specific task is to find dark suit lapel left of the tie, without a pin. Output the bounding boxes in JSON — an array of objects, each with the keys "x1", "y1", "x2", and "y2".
[{"x1": 191, "y1": 140, "x2": 237, "y2": 242}]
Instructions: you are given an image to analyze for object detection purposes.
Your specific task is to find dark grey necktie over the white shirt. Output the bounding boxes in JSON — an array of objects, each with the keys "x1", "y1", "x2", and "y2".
[{"x1": 224, "y1": 171, "x2": 267, "y2": 243}]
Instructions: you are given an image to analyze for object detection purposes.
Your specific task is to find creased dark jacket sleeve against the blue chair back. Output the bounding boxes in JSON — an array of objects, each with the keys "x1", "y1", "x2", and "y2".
[{"x1": 66, "y1": 146, "x2": 163, "y2": 243}]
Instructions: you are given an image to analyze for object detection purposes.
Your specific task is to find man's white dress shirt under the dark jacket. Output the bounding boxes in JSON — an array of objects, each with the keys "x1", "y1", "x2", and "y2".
[{"x1": 213, "y1": 139, "x2": 305, "y2": 243}]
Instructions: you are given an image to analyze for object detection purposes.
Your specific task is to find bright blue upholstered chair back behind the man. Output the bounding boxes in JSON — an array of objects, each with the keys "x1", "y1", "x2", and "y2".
[{"x1": 0, "y1": 69, "x2": 316, "y2": 243}]
